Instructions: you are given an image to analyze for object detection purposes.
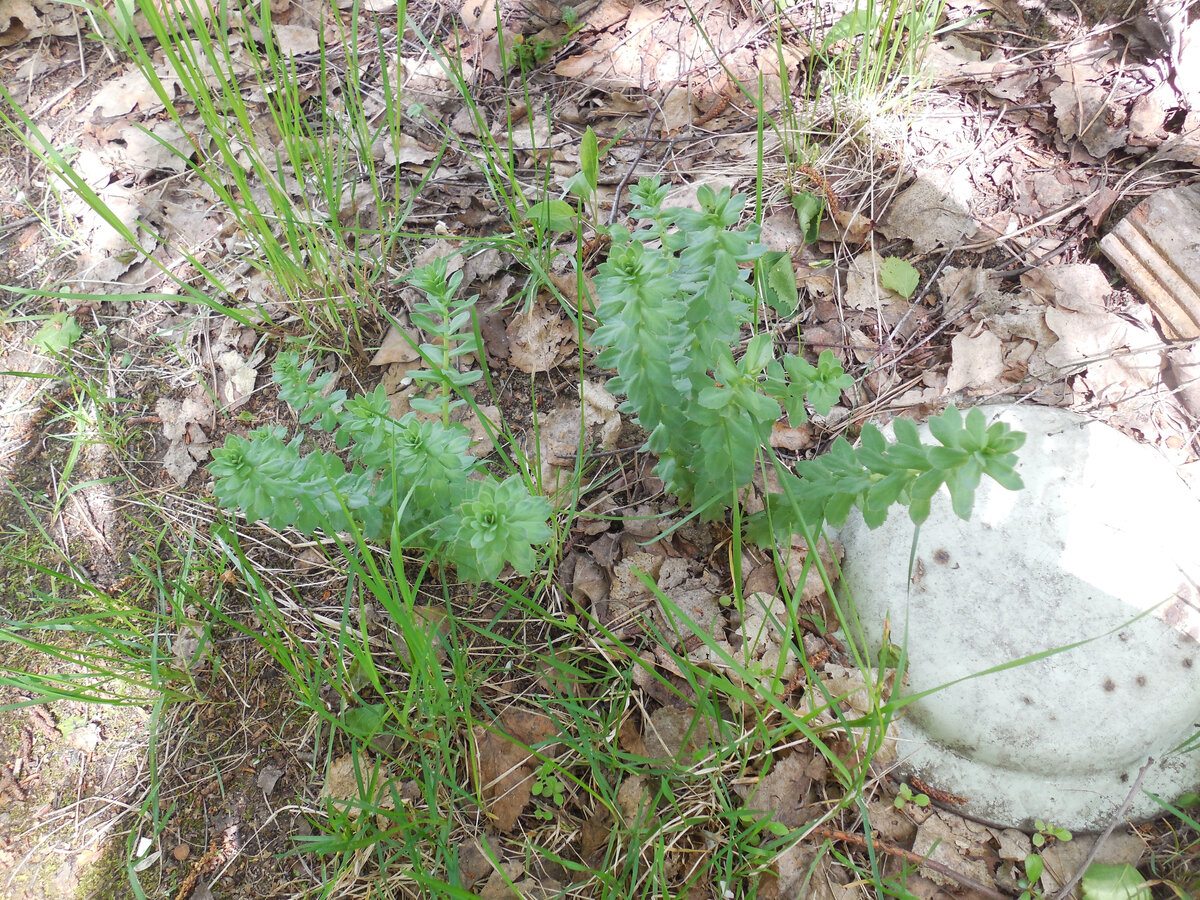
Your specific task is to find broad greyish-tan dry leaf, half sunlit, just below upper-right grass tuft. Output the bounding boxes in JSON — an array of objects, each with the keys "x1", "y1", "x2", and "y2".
[{"x1": 880, "y1": 168, "x2": 976, "y2": 253}]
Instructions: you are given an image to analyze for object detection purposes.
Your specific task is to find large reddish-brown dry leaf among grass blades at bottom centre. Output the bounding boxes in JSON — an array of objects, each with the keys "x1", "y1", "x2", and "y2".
[{"x1": 474, "y1": 707, "x2": 558, "y2": 832}]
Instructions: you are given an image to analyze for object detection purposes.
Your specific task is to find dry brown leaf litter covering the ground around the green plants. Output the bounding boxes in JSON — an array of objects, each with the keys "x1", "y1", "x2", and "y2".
[{"x1": 0, "y1": 0, "x2": 1200, "y2": 898}]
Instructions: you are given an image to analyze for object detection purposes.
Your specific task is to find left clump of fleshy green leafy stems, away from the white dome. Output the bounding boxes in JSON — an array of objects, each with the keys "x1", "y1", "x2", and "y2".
[{"x1": 210, "y1": 263, "x2": 551, "y2": 581}]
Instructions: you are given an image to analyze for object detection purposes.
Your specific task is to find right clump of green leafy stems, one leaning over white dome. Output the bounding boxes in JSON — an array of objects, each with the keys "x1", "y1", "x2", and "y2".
[{"x1": 592, "y1": 179, "x2": 1024, "y2": 544}]
